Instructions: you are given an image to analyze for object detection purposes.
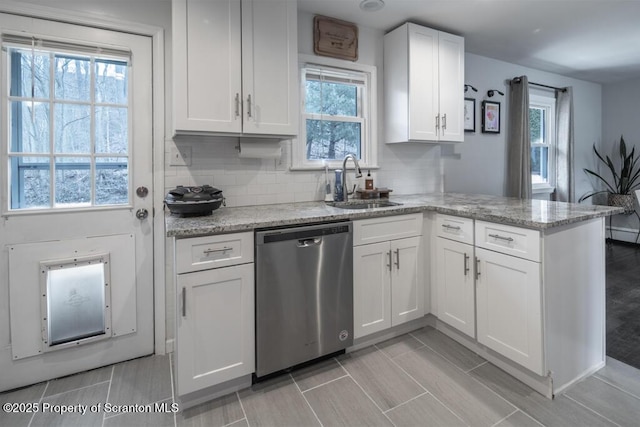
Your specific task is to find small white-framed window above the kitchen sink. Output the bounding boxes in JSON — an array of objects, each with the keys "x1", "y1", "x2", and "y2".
[{"x1": 293, "y1": 57, "x2": 377, "y2": 169}]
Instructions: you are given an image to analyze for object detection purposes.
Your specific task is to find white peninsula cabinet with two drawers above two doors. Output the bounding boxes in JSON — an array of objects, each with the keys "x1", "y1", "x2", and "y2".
[{"x1": 435, "y1": 215, "x2": 544, "y2": 375}]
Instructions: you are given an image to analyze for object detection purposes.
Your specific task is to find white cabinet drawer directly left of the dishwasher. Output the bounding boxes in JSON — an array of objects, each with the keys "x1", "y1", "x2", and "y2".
[{"x1": 175, "y1": 232, "x2": 253, "y2": 274}]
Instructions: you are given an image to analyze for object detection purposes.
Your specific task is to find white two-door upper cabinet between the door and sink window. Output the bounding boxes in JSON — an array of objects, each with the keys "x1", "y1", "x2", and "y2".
[{"x1": 172, "y1": 0, "x2": 299, "y2": 137}]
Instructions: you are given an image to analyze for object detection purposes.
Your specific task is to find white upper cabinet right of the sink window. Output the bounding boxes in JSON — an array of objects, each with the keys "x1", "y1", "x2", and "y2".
[{"x1": 384, "y1": 23, "x2": 464, "y2": 143}]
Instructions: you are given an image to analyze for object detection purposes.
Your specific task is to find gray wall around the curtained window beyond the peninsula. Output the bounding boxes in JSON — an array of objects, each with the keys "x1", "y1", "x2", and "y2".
[{"x1": 442, "y1": 53, "x2": 602, "y2": 201}]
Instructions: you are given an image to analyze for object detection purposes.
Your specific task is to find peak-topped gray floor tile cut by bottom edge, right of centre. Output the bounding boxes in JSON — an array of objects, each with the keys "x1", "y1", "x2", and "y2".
[{"x1": 386, "y1": 393, "x2": 467, "y2": 427}]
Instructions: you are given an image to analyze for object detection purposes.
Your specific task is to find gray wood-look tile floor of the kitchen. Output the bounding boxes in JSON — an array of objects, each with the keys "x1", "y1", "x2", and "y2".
[{"x1": 0, "y1": 327, "x2": 640, "y2": 427}]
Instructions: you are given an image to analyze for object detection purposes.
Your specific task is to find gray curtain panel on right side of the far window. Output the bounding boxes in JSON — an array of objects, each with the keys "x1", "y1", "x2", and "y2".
[{"x1": 555, "y1": 87, "x2": 575, "y2": 202}]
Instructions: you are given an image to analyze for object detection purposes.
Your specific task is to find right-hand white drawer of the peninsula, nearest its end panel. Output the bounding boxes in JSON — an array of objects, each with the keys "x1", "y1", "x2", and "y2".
[{"x1": 476, "y1": 221, "x2": 540, "y2": 262}]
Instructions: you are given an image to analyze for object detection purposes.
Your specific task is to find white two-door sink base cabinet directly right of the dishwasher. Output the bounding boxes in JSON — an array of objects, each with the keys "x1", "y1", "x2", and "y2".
[{"x1": 353, "y1": 214, "x2": 424, "y2": 338}]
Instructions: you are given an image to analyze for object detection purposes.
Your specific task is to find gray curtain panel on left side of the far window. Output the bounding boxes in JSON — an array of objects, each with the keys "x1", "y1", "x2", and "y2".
[{"x1": 507, "y1": 76, "x2": 531, "y2": 199}]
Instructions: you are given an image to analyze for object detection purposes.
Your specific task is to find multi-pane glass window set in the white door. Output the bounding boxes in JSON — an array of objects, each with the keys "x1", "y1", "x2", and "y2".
[{"x1": 3, "y1": 36, "x2": 130, "y2": 210}]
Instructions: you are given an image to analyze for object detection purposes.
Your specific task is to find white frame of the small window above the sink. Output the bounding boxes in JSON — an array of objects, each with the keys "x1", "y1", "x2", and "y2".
[{"x1": 290, "y1": 55, "x2": 379, "y2": 171}]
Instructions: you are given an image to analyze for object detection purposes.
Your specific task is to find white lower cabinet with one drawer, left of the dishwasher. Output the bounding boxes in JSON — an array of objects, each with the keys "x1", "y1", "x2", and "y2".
[{"x1": 175, "y1": 233, "x2": 255, "y2": 396}]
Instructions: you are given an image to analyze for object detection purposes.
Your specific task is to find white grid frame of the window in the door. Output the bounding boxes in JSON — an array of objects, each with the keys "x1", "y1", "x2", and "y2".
[{"x1": 0, "y1": 38, "x2": 133, "y2": 216}]
